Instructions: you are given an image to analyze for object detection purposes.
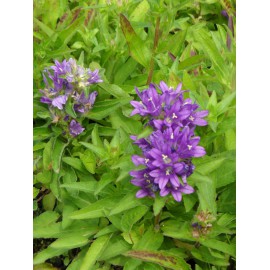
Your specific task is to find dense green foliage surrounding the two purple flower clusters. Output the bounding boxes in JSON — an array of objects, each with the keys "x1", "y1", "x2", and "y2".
[{"x1": 33, "y1": 0, "x2": 236, "y2": 270}]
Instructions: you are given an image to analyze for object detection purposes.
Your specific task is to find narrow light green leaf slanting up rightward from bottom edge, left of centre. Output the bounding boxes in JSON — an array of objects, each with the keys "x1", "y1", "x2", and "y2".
[{"x1": 80, "y1": 235, "x2": 111, "y2": 270}]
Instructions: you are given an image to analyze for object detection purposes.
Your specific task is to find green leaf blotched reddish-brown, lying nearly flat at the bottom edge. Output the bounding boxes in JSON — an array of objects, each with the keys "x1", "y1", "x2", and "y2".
[{"x1": 125, "y1": 250, "x2": 191, "y2": 270}]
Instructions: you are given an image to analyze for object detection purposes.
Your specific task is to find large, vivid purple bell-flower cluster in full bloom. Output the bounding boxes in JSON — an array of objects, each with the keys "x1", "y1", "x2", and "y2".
[{"x1": 130, "y1": 81, "x2": 208, "y2": 201}]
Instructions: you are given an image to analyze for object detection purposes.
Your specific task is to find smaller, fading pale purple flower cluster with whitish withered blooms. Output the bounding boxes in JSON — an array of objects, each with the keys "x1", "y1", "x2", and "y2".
[{"x1": 40, "y1": 58, "x2": 102, "y2": 137}]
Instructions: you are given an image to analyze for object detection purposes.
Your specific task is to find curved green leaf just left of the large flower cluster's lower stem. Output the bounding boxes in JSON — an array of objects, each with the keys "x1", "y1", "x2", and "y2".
[{"x1": 121, "y1": 205, "x2": 148, "y2": 232}]
